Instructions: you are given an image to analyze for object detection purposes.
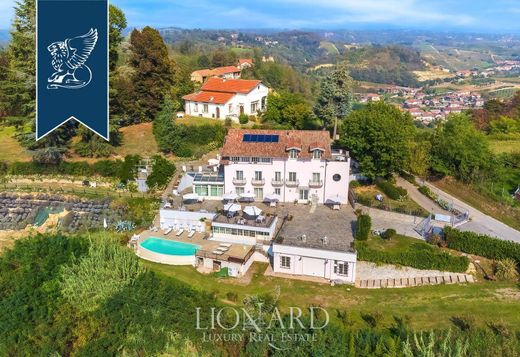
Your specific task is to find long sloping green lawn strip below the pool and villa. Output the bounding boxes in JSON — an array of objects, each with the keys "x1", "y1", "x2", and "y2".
[{"x1": 143, "y1": 262, "x2": 520, "y2": 329}]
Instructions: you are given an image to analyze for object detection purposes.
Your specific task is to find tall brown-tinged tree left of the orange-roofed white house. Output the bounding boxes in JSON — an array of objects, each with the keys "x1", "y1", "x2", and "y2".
[{"x1": 128, "y1": 26, "x2": 173, "y2": 122}]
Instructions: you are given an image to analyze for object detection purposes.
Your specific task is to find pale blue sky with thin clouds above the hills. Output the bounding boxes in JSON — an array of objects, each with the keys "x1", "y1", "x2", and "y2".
[{"x1": 0, "y1": 0, "x2": 520, "y2": 33}]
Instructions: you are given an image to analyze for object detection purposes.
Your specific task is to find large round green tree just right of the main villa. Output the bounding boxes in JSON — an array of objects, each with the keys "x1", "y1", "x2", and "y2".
[{"x1": 340, "y1": 102, "x2": 414, "y2": 179}]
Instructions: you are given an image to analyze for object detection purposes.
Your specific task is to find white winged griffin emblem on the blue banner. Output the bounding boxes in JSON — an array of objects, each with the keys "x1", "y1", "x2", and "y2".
[{"x1": 47, "y1": 29, "x2": 98, "y2": 89}]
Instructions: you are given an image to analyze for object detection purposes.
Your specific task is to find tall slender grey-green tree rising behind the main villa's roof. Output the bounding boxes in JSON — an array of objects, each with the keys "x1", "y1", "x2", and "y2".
[{"x1": 314, "y1": 64, "x2": 352, "y2": 139}]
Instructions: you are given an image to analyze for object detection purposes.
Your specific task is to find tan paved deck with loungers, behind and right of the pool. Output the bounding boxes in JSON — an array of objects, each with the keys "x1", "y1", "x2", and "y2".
[{"x1": 138, "y1": 230, "x2": 254, "y2": 261}]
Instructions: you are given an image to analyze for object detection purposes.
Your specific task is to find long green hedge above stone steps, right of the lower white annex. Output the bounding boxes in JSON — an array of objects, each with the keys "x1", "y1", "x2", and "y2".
[{"x1": 356, "y1": 242, "x2": 469, "y2": 273}]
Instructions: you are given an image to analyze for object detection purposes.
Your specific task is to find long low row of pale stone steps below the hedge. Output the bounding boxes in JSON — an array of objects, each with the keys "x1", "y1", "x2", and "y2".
[{"x1": 355, "y1": 273, "x2": 475, "y2": 289}]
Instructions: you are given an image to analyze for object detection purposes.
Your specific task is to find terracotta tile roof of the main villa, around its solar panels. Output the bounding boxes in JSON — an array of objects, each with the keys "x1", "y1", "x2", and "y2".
[{"x1": 221, "y1": 129, "x2": 332, "y2": 160}]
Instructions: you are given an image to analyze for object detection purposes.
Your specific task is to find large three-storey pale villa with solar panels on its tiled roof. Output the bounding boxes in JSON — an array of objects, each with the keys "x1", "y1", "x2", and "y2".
[{"x1": 221, "y1": 129, "x2": 350, "y2": 204}]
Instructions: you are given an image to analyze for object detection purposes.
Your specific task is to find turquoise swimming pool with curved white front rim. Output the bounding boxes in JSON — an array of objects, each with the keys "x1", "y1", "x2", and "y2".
[{"x1": 137, "y1": 237, "x2": 200, "y2": 265}]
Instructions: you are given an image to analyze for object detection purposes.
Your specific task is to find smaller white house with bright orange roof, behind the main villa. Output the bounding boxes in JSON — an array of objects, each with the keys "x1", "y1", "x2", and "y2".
[{"x1": 183, "y1": 78, "x2": 269, "y2": 119}]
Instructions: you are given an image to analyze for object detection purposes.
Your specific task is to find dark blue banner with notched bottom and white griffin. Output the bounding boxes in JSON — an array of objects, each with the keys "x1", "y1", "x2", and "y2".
[{"x1": 36, "y1": 0, "x2": 109, "y2": 140}]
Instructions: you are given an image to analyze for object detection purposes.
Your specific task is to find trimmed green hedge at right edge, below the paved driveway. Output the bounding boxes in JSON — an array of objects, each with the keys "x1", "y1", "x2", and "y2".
[{"x1": 444, "y1": 227, "x2": 520, "y2": 264}]
